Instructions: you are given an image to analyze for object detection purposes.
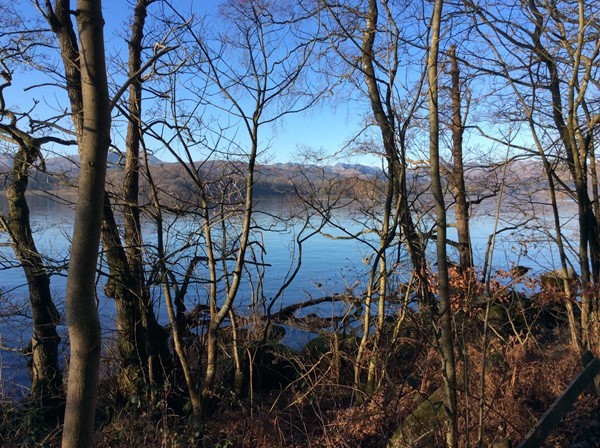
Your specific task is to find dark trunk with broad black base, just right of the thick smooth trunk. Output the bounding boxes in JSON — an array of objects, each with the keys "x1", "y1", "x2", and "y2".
[{"x1": 102, "y1": 0, "x2": 173, "y2": 397}]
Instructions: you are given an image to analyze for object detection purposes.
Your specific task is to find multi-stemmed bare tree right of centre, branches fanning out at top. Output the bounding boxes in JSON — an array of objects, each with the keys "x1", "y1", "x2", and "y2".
[{"x1": 321, "y1": 0, "x2": 431, "y2": 391}]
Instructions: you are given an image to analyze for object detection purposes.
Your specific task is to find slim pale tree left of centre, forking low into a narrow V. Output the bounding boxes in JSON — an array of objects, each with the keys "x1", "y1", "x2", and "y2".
[{"x1": 172, "y1": 0, "x2": 318, "y2": 416}]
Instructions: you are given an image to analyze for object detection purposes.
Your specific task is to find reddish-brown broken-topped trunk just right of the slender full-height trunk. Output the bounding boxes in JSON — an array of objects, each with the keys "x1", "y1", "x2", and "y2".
[{"x1": 448, "y1": 46, "x2": 473, "y2": 272}]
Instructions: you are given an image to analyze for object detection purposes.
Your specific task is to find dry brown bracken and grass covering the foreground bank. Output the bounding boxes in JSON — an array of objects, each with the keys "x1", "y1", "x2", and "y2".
[{"x1": 0, "y1": 302, "x2": 600, "y2": 448}]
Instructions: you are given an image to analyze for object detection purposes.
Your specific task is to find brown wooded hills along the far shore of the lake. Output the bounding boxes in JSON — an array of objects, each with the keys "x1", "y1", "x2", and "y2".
[{"x1": 0, "y1": 152, "x2": 547, "y2": 200}]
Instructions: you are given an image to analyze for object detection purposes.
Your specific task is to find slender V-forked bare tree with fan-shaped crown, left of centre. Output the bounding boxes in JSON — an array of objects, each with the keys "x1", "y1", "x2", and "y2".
[{"x1": 134, "y1": 0, "x2": 326, "y2": 419}]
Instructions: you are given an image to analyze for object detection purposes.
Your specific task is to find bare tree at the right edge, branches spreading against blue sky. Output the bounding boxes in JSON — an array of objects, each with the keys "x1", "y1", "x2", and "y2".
[{"x1": 465, "y1": 0, "x2": 600, "y2": 346}]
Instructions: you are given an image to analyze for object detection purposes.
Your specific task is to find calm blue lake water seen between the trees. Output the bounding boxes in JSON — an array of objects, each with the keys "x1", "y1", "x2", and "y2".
[{"x1": 0, "y1": 196, "x2": 571, "y2": 393}]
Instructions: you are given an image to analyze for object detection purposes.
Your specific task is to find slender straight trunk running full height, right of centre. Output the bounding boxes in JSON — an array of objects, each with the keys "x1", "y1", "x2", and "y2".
[{"x1": 427, "y1": 0, "x2": 458, "y2": 447}]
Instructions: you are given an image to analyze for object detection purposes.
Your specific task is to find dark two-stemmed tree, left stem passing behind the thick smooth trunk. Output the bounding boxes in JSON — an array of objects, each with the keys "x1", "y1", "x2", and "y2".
[{"x1": 45, "y1": 0, "x2": 172, "y2": 398}]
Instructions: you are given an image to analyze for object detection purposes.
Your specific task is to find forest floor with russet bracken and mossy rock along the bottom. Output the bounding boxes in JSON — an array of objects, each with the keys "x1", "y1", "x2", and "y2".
[{"x1": 0, "y1": 288, "x2": 600, "y2": 448}]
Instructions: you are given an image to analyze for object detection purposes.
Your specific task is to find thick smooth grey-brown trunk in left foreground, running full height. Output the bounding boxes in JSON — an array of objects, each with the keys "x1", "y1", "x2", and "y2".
[{"x1": 61, "y1": 0, "x2": 111, "y2": 448}]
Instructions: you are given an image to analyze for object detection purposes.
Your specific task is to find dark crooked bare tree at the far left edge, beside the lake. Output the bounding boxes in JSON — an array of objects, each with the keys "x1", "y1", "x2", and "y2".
[{"x1": 0, "y1": 25, "x2": 69, "y2": 411}]
